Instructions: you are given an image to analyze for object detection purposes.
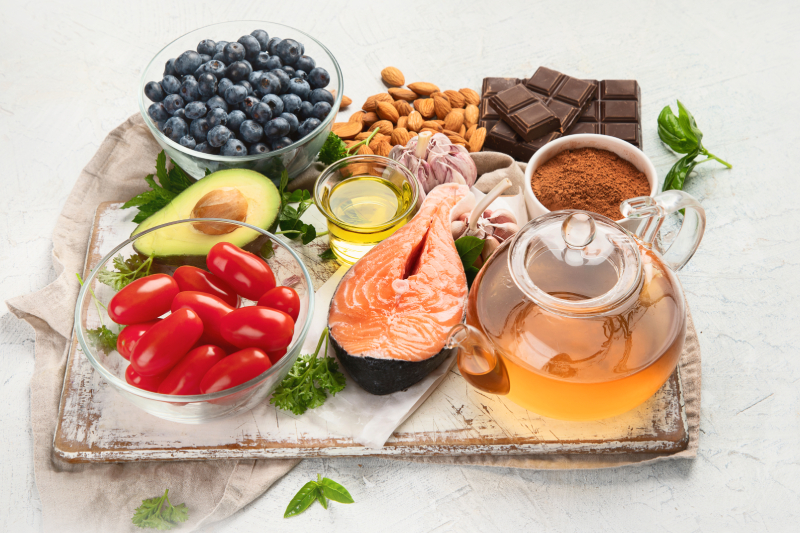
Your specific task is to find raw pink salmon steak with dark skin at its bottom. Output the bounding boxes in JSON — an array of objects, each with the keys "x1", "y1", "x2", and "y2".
[{"x1": 328, "y1": 183, "x2": 475, "y2": 394}]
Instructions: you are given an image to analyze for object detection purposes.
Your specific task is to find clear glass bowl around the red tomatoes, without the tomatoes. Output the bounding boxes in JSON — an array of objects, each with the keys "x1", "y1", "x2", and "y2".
[{"x1": 75, "y1": 219, "x2": 314, "y2": 424}]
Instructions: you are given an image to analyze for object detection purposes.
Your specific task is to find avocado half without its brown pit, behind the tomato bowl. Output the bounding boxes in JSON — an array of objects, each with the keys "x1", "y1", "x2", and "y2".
[{"x1": 131, "y1": 169, "x2": 281, "y2": 268}]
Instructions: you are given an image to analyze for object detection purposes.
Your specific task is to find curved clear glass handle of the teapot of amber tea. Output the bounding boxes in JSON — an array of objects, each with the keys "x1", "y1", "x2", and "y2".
[{"x1": 620, "y1": 189, "x2": 706, "y2": 271}]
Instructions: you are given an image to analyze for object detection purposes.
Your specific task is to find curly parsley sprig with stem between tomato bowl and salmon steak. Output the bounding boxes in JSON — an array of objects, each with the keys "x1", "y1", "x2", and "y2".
[{"x1": 269, "y1": 328, "x2": 346, "y2": 416}]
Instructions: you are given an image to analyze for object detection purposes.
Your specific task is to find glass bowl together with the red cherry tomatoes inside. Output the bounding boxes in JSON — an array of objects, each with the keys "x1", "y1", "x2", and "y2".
[{"x1": 75, "y1": 219, "x2": 314, "y2": 424}]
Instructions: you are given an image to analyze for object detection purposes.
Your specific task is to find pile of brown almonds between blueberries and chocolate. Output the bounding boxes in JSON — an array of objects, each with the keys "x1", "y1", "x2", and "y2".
[{"x1": 333, "y1": 67, "x2": 486, "y2": 156}]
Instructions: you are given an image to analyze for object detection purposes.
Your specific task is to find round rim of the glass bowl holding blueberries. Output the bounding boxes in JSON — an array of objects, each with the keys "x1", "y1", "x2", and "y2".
[{"x1": 137, "y1": 20, "x2": 343, "y2": 163}]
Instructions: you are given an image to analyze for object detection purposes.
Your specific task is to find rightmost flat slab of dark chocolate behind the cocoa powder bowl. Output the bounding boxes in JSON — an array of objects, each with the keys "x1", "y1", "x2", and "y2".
[{"x1": 566, "y1": 80, "x2": 642, "y2": 150}]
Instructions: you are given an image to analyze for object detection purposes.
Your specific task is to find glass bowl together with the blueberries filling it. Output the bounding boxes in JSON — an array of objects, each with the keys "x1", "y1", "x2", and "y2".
[{"x1": 139, "y1": 21, "x2": 342, "y2": 180}]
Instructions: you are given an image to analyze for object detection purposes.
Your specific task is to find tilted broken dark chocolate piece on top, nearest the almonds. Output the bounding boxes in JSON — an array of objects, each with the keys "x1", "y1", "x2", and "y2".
[{"x1": 489, "y1": 84, "x2": 561, "y2": 141}]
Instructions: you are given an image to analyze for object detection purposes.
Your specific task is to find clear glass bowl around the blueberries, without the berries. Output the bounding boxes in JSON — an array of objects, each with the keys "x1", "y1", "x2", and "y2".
[{"x1": 138, "y1": 20, "x2": 343, "y2": 180}]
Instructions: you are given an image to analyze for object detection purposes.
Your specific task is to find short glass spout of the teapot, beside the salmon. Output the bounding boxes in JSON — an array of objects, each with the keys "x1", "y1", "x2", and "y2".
[{"x1": 445, "y1": 324, "x2": 511, "y2": 395}]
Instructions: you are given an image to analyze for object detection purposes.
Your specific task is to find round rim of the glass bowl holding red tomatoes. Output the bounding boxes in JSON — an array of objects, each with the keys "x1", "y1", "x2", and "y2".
[{"x1": 74, "y1": 218, "x2": 315, "y2": 403}]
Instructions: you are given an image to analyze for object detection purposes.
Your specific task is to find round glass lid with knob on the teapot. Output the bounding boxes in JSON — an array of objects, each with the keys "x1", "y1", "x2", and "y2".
[{"x1": 508, "y1": 210, "x2": 642, "y2": 315}]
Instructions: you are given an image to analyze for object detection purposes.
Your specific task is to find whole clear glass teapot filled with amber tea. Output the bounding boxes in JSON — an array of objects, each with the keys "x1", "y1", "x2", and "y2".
[{"x1": 448, "y1": 190, "x2": 705, "y2": 420}]
